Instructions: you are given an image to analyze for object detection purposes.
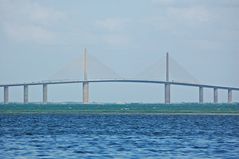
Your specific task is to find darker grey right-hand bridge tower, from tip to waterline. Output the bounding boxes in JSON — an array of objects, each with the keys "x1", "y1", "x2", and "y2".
[{"x1": 164, "y1": 52, "x2": 170, "y2": 104}]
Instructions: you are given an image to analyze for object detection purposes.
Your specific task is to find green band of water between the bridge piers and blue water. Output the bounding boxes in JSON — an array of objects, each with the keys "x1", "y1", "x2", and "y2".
[{"x1": 0, "y1": 103, "x2": 239, "y2": 115}]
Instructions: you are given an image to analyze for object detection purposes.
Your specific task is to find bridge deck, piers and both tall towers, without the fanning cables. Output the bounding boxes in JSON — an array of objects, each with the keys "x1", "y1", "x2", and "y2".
[{"x1": 0, "y1": 49, "x2": 239, "y2": 104}]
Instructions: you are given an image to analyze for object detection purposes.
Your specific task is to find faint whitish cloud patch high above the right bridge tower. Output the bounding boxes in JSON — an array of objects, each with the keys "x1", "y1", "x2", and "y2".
[{"x1": 142, "y1": 3, "x2": 211, "y2": 34}]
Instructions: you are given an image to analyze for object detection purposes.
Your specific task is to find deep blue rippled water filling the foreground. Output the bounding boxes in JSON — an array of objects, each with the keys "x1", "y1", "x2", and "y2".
[{"x1": 0, "y1": 114, "x2": 239, "y2": 159}]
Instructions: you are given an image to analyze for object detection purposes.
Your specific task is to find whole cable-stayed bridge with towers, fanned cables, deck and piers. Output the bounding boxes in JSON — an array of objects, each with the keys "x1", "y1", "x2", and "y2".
[{"x1": 0, "y1": 49, "x2": 239, "y2": 104}]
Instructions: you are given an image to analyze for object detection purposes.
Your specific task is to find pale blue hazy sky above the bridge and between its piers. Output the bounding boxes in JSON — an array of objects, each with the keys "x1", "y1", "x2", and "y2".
[{"x1": 0, "y1": 0, "x2": 239, "y2": 102}]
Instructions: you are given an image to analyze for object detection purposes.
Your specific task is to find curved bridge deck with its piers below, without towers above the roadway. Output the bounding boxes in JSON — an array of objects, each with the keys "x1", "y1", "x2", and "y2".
[{"x1": 0, "y1": 79, "x2": 239, "y2": 103}]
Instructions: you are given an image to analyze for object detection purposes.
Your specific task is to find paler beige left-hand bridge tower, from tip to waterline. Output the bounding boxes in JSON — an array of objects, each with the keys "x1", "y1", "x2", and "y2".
[{"x1": 83, "y1": 48, "x2": 89, "y2": 104}]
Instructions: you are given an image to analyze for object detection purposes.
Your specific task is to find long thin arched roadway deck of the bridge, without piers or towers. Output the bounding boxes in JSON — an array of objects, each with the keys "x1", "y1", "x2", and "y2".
[{"x1": 0, "y1": 79, "x2": 239, "y2": 91}]
